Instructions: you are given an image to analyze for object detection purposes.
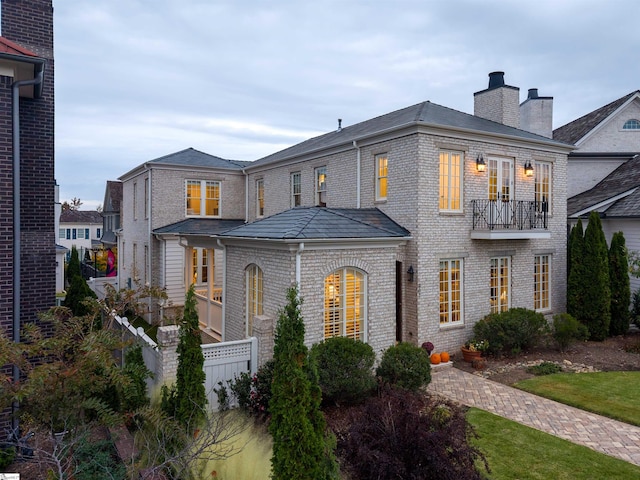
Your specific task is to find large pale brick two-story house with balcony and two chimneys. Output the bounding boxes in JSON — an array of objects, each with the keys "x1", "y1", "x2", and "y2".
[{"x1": 121, "y1": 72, "x2": 573, "y2": 352}]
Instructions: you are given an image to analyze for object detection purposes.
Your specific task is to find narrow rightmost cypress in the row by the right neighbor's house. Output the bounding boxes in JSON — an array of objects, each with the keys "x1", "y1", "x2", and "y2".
[{"x1": 609, "y1": 232, "x2": 631, "y2": 335}]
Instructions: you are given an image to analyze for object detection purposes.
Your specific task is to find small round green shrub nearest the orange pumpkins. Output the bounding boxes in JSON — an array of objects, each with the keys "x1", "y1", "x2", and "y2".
[{"x1": 376, "y1": 342, "x2": 431, "y2": 391}]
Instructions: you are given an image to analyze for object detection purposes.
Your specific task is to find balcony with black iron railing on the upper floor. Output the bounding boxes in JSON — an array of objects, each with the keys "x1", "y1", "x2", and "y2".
[{"x1": 471, "y1": 200, "x2": 551, "y2": 240}]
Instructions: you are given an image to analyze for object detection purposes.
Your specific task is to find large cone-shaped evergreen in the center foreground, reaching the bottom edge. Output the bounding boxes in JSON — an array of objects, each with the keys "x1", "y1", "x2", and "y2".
[{"x1": 269, "y1": 288, "x2": 338, "y2": 480}]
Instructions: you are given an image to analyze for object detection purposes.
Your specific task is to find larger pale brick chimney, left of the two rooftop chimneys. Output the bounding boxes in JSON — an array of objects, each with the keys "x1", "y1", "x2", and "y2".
[{"x1": 473, "y1": 72, "x2": 520, "y2": 128}]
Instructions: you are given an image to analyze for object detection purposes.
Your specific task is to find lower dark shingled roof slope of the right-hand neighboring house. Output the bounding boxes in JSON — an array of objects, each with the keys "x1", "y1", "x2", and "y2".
[{"x1": 567, "y1": 155, "x2": 640, "y2": 217}]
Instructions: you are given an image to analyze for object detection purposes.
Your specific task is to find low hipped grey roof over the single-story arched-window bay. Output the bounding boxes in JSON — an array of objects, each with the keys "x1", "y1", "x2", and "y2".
[{"x1": 221, "y1": 207, "x2": 411, "y2": 240}]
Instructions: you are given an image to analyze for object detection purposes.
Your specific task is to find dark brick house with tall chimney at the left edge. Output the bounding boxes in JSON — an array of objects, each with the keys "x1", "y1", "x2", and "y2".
[{"x1": 0, "y1": 0, "x2": 56, "y2": 431}]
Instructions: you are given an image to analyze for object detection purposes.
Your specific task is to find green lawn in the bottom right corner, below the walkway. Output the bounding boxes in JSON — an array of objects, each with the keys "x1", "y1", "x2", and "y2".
[{"x1": 467, "y1": 406, "x2": 640, "y2": 480}]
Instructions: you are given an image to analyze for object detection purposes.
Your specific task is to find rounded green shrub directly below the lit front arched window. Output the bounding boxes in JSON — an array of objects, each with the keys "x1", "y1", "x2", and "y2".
[{"x1": 311, "y1": 337, "x2": 376, "y2": 404}]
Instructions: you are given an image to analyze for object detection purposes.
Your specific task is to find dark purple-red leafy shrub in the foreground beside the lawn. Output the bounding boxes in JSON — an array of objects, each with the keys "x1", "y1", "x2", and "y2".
[{"x1": 338, "y1": 390, "x2": 486, "y2": 480}]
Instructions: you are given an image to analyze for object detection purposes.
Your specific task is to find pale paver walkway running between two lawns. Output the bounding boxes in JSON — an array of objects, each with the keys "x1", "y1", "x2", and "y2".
[{"x1": 427, "y1": 368, "x2": 640, "y2": 465}]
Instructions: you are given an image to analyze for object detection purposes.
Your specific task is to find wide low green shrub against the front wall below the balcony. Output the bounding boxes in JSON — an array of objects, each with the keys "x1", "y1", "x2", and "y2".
[{"x1": 473, "y1": 308, "x2": 548, "y2": 355}]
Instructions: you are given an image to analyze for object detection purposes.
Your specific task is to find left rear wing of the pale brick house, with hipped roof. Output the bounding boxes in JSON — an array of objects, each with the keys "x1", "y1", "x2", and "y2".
[{"x1": 118, "y1": 148, "x2": 247, "y2": 324}]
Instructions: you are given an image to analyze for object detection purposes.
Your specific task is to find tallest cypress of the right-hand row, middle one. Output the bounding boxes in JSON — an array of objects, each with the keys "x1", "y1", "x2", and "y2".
[{"x1": 579, "y1": 211, "x2": 611, "y2": 341}]
